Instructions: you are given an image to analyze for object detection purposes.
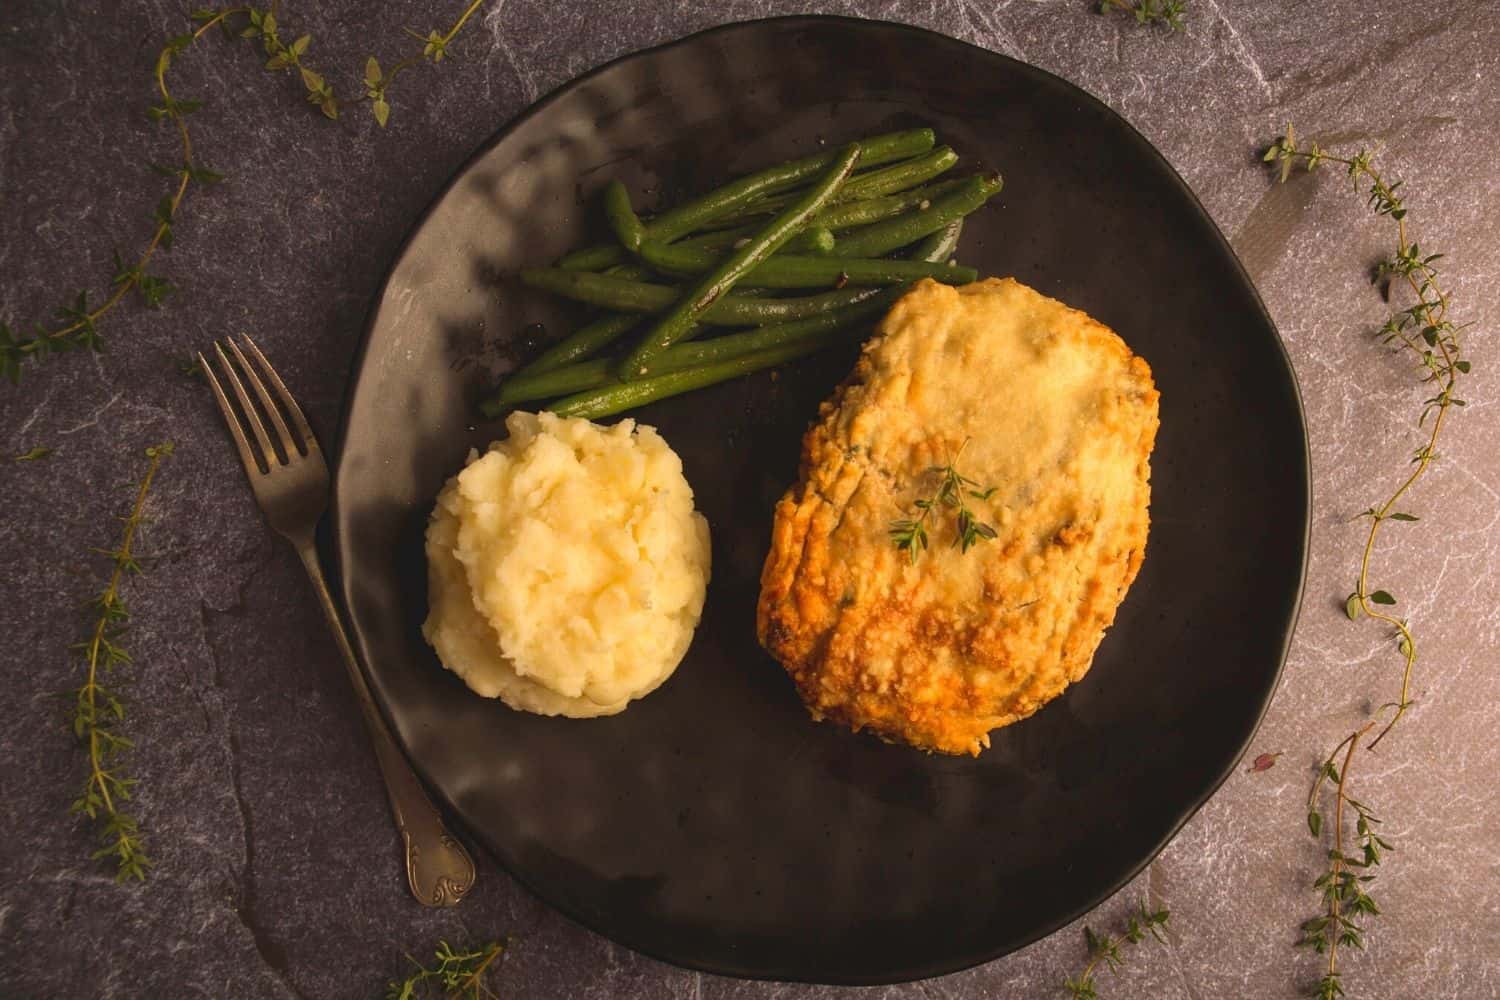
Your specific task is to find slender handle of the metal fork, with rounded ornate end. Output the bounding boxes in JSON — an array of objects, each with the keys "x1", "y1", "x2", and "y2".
[{"x1": 296, "y1": 538, "x2": 476, "y2": 907}]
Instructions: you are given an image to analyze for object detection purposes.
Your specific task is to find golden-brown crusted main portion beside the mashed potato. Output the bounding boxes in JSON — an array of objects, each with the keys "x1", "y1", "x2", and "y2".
[{"x1": 756, "y1": 279, "x2": 1158, "y2": 754}]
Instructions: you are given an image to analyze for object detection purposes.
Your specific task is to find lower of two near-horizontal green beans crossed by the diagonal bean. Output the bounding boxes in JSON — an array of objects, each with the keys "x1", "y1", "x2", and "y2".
[{"x1": 521, "y1": 267, "x2": 876, "y2": 327}]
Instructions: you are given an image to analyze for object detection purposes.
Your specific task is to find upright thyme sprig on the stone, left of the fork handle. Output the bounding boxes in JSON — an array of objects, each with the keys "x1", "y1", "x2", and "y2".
[{"x1": 69, "y1": 442, "x2": 173, "y2": 882}]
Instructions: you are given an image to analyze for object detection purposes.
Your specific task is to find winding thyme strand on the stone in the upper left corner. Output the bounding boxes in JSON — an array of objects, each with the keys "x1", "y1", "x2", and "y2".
[{"x1": 0, "y1": 0, "x2": 485, "y2": 382}]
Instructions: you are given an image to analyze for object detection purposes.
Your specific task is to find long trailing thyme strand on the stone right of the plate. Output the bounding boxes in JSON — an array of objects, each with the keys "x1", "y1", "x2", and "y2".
[{"x1": 1265, "y1": 124, "x2": 1472, "y2": 1000}]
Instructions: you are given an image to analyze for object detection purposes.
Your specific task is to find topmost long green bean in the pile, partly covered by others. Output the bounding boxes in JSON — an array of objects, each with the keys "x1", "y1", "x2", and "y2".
[{"x1": 558, "y1": 129, "x2": 935, "y2": 271}]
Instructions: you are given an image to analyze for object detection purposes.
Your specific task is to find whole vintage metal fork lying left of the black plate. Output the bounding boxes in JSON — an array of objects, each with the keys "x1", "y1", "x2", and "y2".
[{"x1": 198, "y1": 336, "x2": 474, "y2": 906}]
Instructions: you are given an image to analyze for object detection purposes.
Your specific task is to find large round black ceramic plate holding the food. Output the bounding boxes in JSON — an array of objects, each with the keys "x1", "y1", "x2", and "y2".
[{"x1": 336, "y1": 18, "x2": 1308, "y2": 982}]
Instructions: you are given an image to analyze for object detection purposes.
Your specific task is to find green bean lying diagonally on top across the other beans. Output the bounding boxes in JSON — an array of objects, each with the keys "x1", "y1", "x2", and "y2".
[{"x1": 620, "y1": 142, "x2": 860, "y2": 374}]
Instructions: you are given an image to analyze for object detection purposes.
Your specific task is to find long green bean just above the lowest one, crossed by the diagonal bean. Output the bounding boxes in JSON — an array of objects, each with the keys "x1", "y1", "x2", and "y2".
[{"x1": 480, "y1": 288, "x2": 906, "y2": 418}]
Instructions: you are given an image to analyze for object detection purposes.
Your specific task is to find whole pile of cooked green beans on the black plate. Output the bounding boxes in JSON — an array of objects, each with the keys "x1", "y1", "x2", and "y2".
[{"x1": 482, "y1": 129, "x2": 1001, "y2": 418}]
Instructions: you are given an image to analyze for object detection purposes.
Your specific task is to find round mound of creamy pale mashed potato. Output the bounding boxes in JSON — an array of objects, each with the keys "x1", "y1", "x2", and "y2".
[{"x1": 423, "y1": 412, "x2": 710, "y2": 718}]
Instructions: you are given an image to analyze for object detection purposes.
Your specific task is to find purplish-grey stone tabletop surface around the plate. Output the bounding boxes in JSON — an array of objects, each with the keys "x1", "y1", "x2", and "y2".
[{"x1": 0, "y1": 0, "x2": 1500, "y2": 1000}]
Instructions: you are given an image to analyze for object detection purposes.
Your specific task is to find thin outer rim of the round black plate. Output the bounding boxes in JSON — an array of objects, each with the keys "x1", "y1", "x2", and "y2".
[{"x1": 324, "y1": 13, "x2": 1314, "y2": 985}]
